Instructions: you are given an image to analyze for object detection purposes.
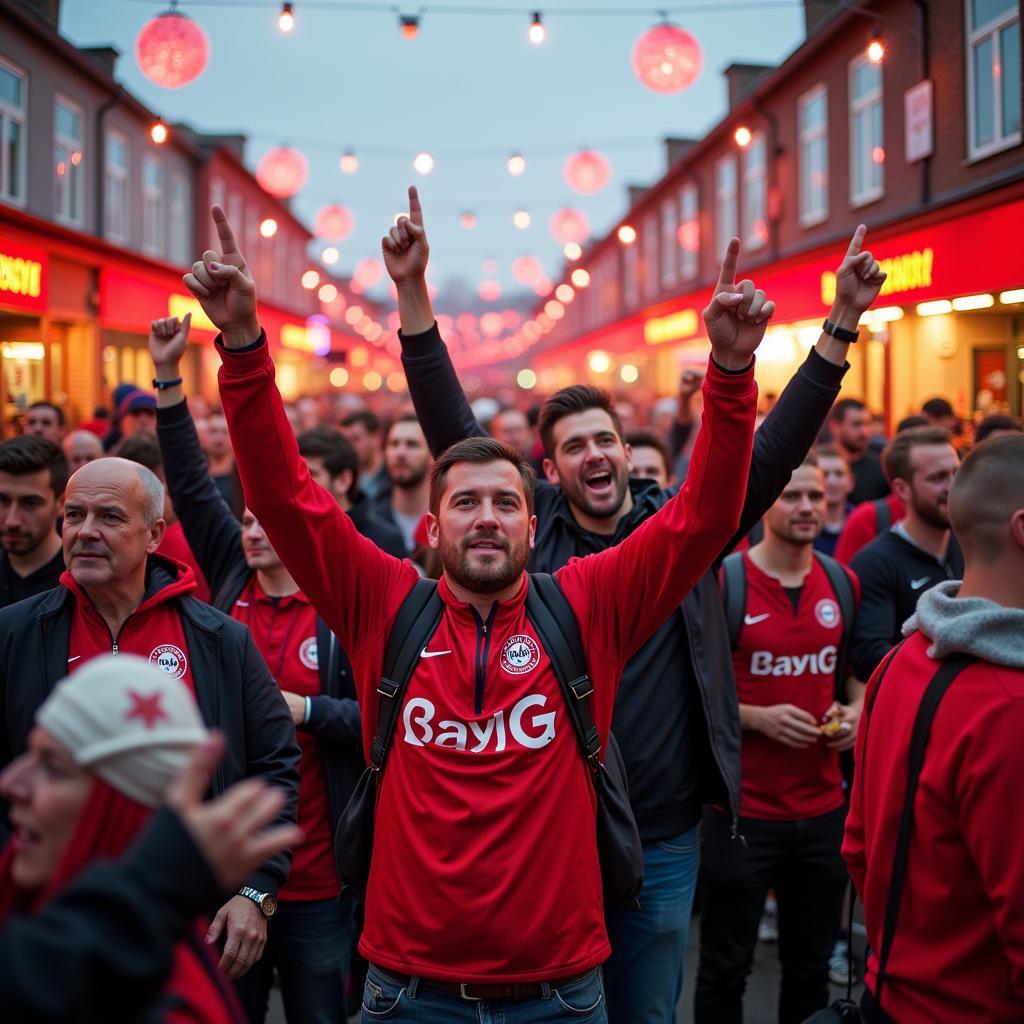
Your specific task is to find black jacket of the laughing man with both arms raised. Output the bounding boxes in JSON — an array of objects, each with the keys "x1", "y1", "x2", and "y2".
[{"x1": 402, "y1": 327, "x2": 846, "y2": 841}]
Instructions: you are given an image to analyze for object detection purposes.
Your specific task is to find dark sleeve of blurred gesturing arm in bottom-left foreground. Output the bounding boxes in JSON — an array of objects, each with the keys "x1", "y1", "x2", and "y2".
[{"x1": 0, "y1": 809, "x2": 224, "y2": 1024}]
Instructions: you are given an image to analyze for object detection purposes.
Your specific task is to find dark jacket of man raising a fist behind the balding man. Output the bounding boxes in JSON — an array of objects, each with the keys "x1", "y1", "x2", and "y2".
[{"x1": 157, "y1": 401, "x2": 364, "y2": 856}]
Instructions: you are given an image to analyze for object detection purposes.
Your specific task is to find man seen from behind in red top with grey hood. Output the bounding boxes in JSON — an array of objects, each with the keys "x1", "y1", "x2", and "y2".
[{"x1": 843, "y1": 436, "x2": 1024, "y2": 1024}]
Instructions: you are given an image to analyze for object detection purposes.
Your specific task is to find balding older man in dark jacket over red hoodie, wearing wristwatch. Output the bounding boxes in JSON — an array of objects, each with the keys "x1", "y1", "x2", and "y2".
[{"x1": 0, "y1": 458, "x2": 299, "y2": 991}]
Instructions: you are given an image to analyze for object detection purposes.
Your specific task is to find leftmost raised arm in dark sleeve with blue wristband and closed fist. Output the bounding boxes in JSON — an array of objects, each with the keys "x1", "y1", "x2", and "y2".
[{"x1": 150, "y1": 313, "x2": 246, "y2": 598}]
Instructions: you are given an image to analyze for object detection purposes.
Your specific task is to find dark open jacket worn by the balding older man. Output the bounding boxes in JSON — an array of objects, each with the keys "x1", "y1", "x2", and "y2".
[{"x1": 0, "y1": 555, "x2": 299, "y2": 895}]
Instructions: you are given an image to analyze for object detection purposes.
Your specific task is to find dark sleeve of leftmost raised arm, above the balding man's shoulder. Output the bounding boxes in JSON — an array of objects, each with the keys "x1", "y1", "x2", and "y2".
[{"x1": 157, "y1": 401, "x2": 246, "y2": 596}]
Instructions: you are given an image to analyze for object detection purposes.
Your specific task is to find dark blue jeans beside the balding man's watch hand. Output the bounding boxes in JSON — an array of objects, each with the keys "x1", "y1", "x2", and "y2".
[{"x1": 237, "y1": 896, "x2": 355, "y2": 1024}]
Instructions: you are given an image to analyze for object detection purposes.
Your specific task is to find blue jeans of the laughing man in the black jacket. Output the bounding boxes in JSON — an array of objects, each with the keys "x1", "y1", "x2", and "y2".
[{"x1": 604, "y1": 826, "x2": 700, "y2": 1024}]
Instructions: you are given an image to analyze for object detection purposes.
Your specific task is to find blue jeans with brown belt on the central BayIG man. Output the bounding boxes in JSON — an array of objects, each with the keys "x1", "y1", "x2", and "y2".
[{"x1": 362, "y1": 964, "x2": 608, "y2": 1024}]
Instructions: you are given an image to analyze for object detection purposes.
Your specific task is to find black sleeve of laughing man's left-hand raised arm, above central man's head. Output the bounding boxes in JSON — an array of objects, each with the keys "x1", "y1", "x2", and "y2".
[{"x1": 398, "y1": 324, "x2": 486, "y2": 458}]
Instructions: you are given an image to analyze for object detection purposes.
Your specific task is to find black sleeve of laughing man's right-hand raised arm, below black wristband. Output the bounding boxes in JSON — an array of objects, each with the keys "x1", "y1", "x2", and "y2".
[{"x1": 719, "y1": 348, "x2": 850, "y2": 559}]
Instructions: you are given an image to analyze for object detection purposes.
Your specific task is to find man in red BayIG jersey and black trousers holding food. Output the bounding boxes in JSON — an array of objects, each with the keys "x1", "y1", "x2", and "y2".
[{"x1": 694, "y1": 456, "x2": 863, "y2": 1024}]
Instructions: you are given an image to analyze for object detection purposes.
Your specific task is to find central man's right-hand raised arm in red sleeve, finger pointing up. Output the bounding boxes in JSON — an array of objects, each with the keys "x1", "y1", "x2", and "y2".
[{"x1": 558, "y1": 239, "x2": 761, "y2": 665}]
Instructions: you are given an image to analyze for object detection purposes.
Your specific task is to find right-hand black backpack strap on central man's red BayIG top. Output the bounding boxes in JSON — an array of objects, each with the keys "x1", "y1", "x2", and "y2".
[{"x1": 526, "y1": 572, "x2": 601, "y2": 772}]
